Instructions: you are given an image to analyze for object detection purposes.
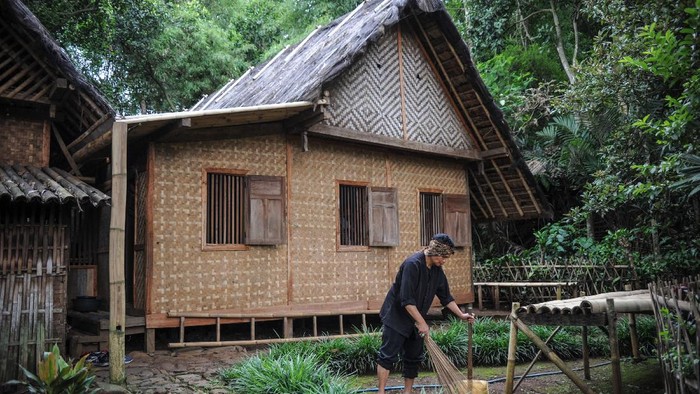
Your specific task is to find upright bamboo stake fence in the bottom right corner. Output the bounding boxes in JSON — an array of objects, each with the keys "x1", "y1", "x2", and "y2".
[{"x1": 649, "y1": 277, "x2": 700, "y2": 394}]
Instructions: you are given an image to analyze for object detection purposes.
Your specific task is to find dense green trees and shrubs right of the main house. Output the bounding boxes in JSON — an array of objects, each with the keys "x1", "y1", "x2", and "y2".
[{"x1": 460, "y1": 0, "x2": 700, "y2": 281}]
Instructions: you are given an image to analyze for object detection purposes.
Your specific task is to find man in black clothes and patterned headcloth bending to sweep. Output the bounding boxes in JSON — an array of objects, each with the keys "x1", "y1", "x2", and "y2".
[{"x1": 377, "y1": 233, "x2": 474, "y2": 394}]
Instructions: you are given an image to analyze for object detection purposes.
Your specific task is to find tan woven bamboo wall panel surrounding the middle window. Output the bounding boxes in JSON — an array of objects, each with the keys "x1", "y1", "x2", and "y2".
[{"x1": 289, "y1": 139, "x2": 396, "y2": 303}]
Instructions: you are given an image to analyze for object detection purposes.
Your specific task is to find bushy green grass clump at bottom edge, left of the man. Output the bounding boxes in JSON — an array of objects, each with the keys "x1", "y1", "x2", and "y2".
[{"x1": 219, "y1": 351, "x2": 357, "y2": 394}]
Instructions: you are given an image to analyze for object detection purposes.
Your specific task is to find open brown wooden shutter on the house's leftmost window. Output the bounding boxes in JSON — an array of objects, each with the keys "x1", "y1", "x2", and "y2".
[{"x1": 245, "y1": 176, "x2": 287, "y2": 245}]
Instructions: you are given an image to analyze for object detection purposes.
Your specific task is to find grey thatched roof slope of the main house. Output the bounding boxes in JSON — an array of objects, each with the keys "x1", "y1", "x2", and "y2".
[{"x1": 192, "y1": 0, "x2": 442, "y2": 110}]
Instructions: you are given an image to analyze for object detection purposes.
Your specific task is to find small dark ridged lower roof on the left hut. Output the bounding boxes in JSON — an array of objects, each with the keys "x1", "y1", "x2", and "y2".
[{"x1": 0, "y1": 164, "x2": 110, "y2": 207}]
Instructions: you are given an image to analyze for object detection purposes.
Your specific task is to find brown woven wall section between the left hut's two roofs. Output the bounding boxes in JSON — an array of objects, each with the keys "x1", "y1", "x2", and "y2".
[{"x1": 0, "y1": 117, "x2": 50, "y2": 167}]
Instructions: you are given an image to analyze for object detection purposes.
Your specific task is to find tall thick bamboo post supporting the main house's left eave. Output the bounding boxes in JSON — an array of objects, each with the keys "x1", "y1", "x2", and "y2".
[{"x1": 109, "y1": 122, "x2": 127, "y2": 384}]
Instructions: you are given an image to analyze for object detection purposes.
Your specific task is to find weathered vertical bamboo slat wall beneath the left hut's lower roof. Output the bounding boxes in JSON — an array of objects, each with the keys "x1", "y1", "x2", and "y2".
[{"x1": 0, "y1": 224, "x2": 67, "y2": 382}]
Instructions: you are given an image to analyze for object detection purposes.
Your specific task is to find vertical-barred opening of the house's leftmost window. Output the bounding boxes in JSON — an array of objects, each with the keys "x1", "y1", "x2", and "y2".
[{"x1": 205, "y1": 172, "x2": 245, "y2": 245}]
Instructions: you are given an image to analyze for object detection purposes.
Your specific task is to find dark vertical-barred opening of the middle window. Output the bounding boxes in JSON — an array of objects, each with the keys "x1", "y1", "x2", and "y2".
[{"x1": 339, "y1": 185, "x2": 369, "y2": 246}]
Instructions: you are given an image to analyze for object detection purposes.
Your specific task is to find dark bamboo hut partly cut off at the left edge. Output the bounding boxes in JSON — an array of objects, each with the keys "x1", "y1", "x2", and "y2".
[{"x1": 0, "y1": 0, "x2": 113, "y2": 383}]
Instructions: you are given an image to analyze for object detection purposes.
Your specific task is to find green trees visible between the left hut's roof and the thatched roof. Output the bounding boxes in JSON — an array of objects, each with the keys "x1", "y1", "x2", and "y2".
[{"x1": 26, "y1": 0, "x2": 358, "y2": 115}]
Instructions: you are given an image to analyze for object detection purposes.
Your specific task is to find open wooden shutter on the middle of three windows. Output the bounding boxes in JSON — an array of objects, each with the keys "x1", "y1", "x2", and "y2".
[{"x1": 369, "y1": 187, "x2": 399, "y2": 246}]
